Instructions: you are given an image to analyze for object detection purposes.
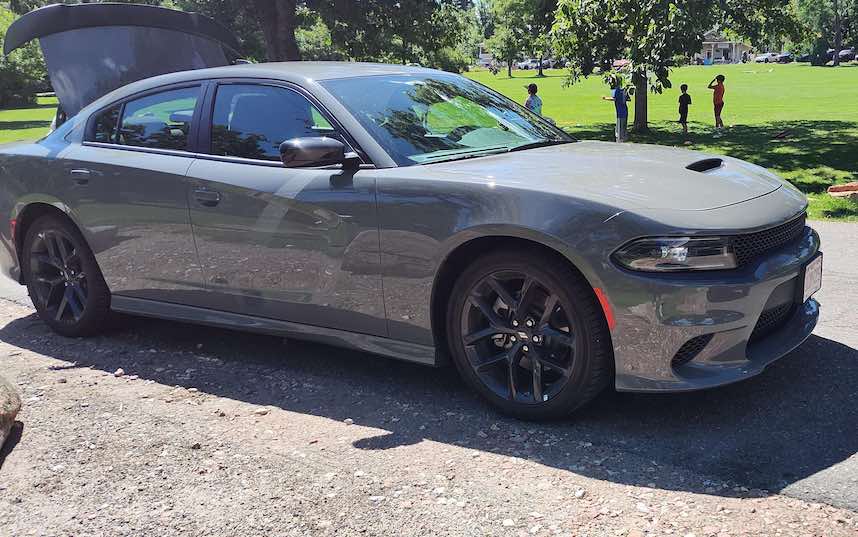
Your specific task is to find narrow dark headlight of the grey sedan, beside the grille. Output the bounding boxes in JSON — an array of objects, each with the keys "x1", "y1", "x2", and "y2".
[{"x1": 614, "y1": 237, "x2": 739, "y2": 272}]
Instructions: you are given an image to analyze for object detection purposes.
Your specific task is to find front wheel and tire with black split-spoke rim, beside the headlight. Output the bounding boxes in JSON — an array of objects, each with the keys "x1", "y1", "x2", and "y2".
[{"x1": 446, "y1": 250, "x2": 613, "y2": 421}]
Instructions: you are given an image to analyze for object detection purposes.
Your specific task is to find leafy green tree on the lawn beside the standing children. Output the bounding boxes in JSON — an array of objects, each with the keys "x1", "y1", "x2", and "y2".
[{"x1": 552, "y1": 0, "x2": 797, "y2": 131}]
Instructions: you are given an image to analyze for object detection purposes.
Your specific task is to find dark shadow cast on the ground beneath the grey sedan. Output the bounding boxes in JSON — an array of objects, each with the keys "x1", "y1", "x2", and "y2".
[{"x1": 0, "y1": 315, "x2": 858, "y2": 502}]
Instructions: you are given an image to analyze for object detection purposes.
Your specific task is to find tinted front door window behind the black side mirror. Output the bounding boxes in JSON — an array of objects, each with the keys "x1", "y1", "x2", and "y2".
[{"x1": 211, "y1": 84, "x2": 338, "y2": 161}]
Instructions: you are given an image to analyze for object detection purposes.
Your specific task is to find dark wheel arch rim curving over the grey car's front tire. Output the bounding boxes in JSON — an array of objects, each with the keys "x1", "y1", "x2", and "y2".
[{"x1": 430, "y1": 229, "x2": 608, "y2": 362}]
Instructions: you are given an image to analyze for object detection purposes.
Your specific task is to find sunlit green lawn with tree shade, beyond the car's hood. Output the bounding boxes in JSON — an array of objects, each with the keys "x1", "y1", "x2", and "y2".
[{"x1": 468, "y1": 64, "x2": 858, "y2": 221}]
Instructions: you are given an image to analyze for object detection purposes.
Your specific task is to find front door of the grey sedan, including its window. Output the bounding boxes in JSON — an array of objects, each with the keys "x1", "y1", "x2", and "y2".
[{"x1": 188, "y1": 83, "x2": 387, "y2": 335}]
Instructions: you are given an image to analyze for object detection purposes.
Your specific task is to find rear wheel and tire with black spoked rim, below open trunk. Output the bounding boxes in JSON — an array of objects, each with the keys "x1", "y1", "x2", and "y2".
[{"x1": 21, "y1": 215, "x2": 110, "y2": 337}]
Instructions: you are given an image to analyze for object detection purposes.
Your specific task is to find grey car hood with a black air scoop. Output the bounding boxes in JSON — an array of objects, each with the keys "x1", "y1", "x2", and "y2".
[{"x1": 419, "y1": 142, "x2": 784, "y2": 211}]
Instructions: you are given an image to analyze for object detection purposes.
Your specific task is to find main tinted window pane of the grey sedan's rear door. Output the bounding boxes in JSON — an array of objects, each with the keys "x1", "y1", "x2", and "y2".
[{"x1": 117, "y1": 87, "x2": 200, "y2": 150}]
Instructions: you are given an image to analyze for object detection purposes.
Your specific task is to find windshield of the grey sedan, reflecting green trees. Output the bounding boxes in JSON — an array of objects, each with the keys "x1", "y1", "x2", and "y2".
[{"x1": 322, "y1": 74, "x2": 574, "y2": 166}]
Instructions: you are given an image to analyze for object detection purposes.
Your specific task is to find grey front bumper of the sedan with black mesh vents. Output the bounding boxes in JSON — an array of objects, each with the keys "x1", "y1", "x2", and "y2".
[{"x1": 606, "y1": 224, "x2": 820, "y2": 392}]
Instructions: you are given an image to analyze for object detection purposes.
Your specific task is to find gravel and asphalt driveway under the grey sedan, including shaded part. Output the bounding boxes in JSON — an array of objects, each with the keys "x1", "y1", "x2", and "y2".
[{"x1": 0, "y1": 223, "x2": 858, "y2": 537}]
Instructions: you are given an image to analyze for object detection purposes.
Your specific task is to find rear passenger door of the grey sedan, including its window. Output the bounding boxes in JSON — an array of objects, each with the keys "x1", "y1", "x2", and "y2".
[{"x1": 62, "y1": 84, "x2": 204, "y2": 303}]
